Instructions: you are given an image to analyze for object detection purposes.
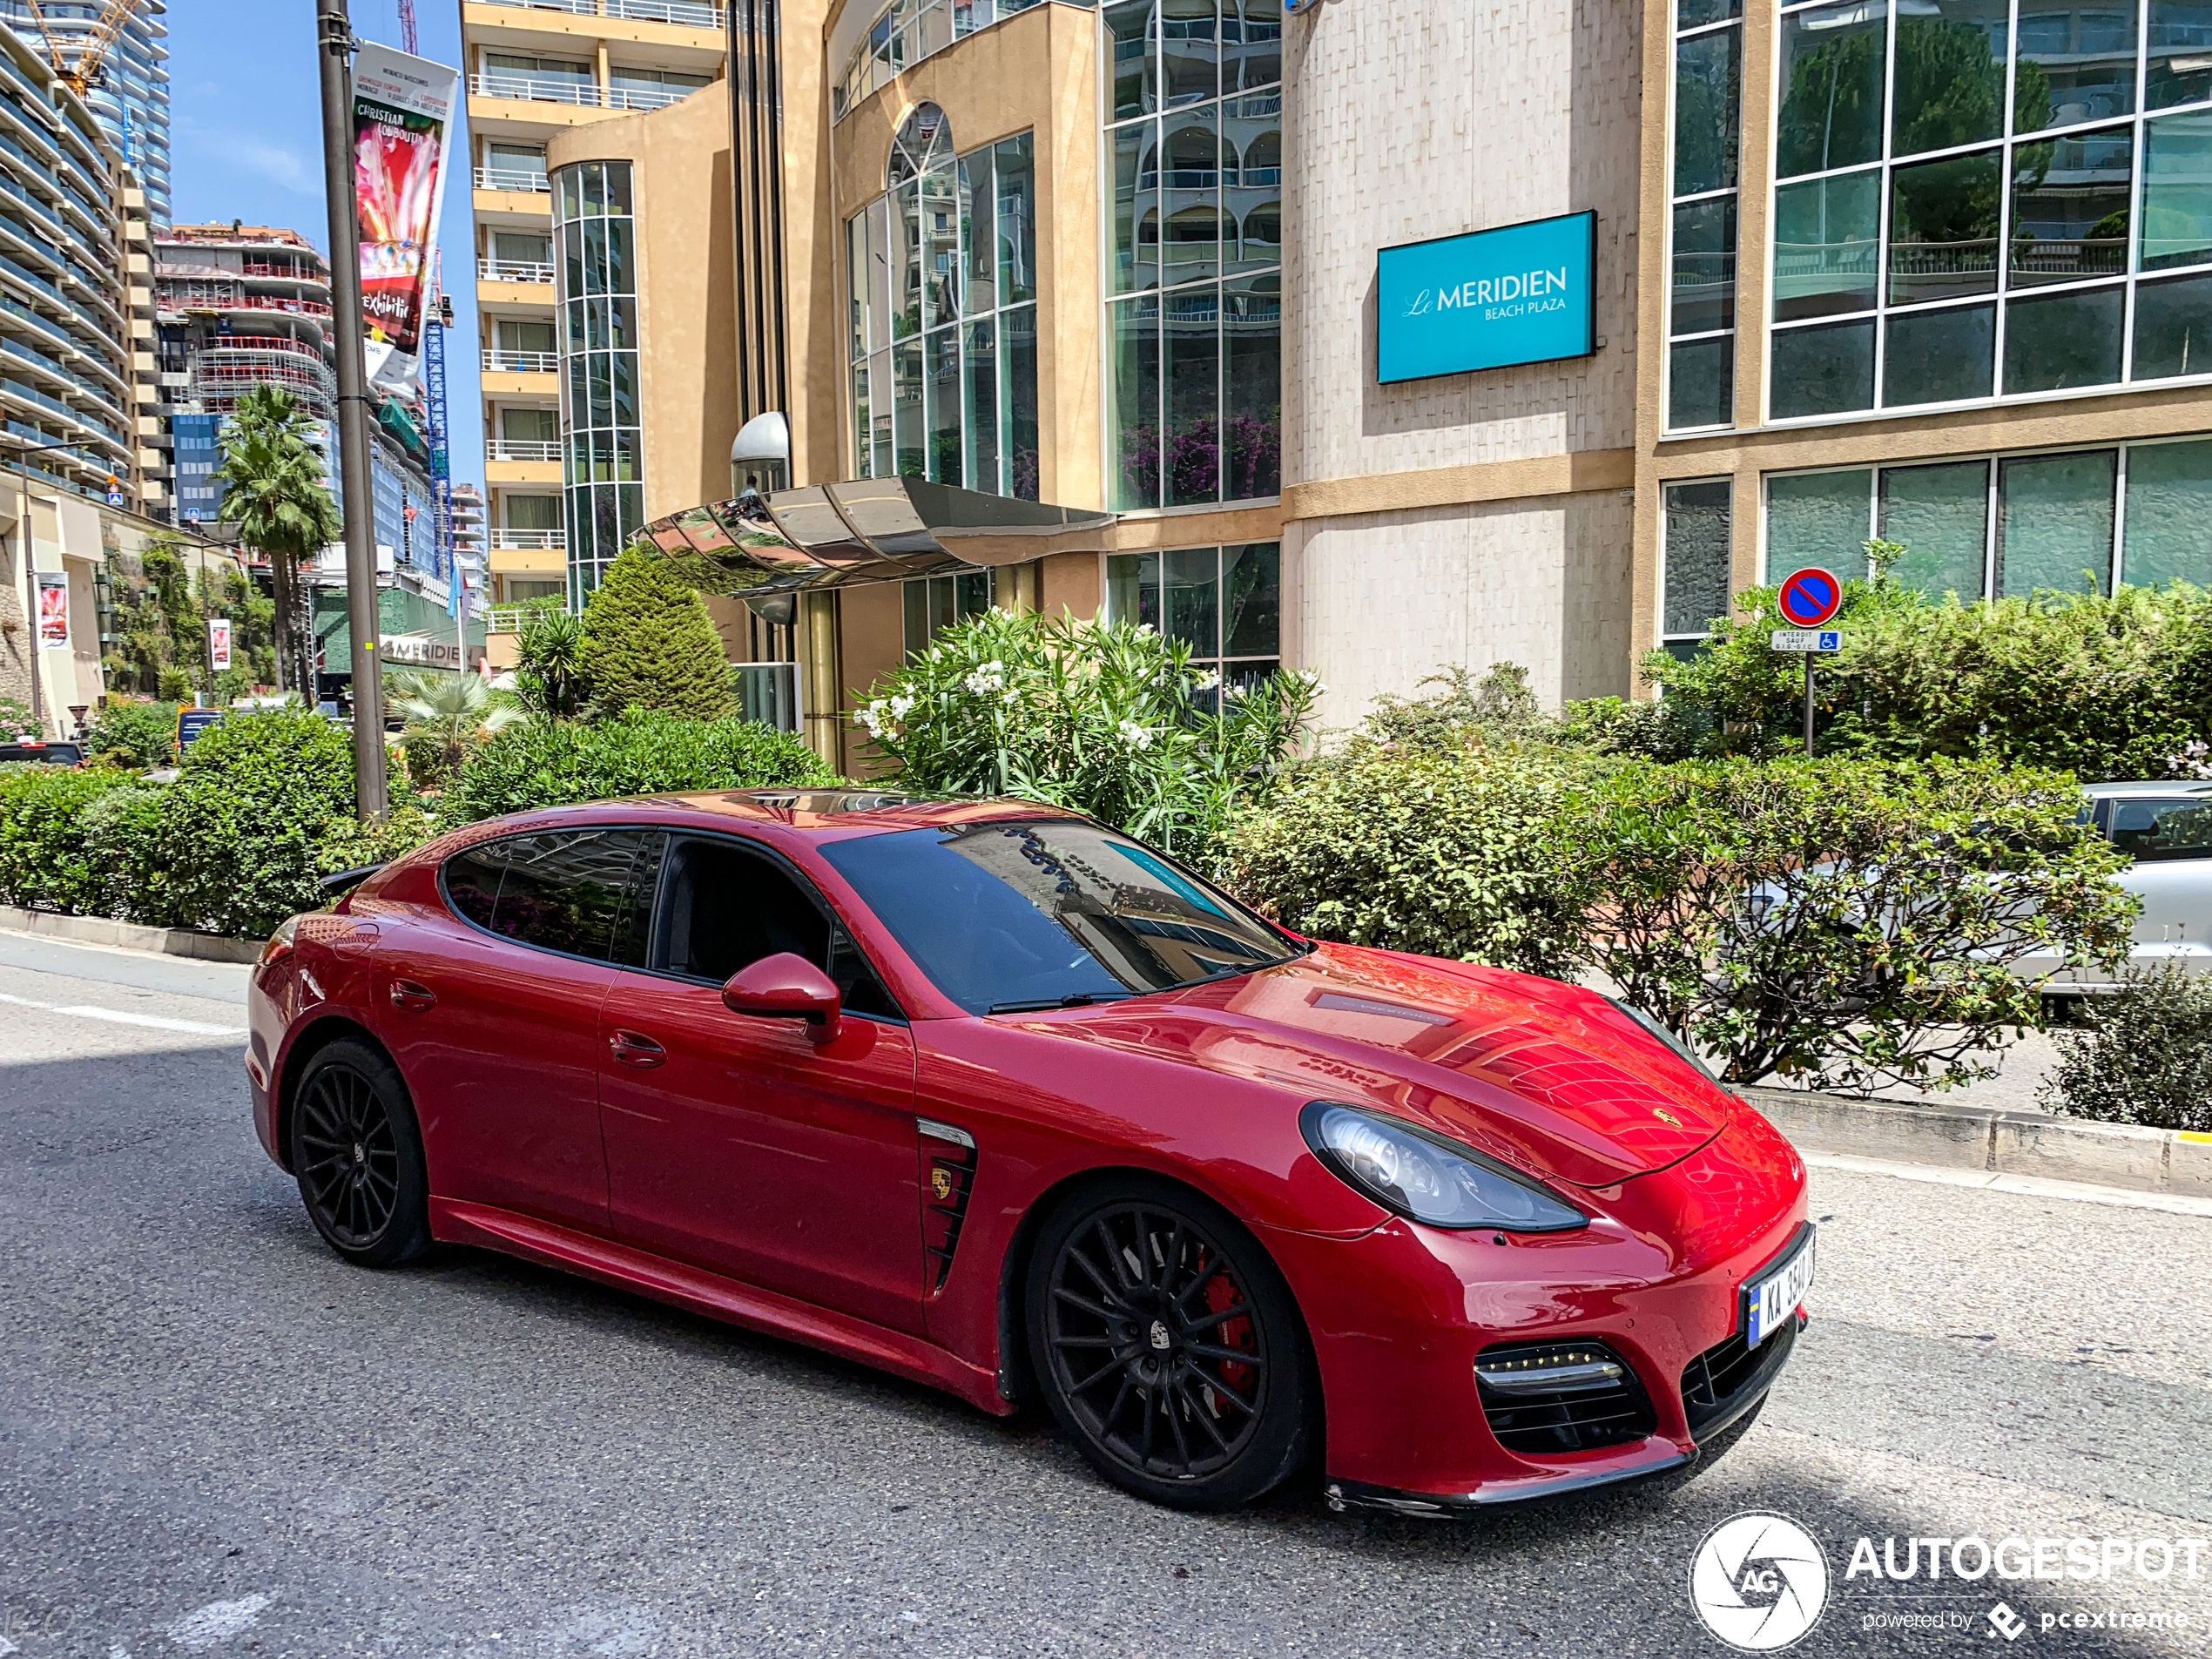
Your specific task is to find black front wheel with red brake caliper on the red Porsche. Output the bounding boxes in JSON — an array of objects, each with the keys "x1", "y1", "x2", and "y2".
[{"x1": 1028, "y1": 1179, "x2": 1318, "y2": 1508}]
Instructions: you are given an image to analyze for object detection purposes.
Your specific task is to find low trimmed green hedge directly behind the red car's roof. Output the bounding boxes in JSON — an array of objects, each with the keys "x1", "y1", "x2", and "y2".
[{"x1": 440, "y1": 710, "x2": 840, "y2": 823}]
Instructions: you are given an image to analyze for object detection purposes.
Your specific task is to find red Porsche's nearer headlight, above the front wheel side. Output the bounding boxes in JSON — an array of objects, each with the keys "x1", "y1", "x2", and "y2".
[{"x1": 1298, "y1": 1099, "x2": 1590, "y2": 1232}]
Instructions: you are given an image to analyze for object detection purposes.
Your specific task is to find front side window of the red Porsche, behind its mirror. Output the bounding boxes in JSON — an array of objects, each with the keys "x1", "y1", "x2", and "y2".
[{"x1": 657, "y1": 840, "x2": 898, "y2": 1017}]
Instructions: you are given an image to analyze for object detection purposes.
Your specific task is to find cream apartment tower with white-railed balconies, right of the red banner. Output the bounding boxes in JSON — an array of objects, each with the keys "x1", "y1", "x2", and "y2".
[{"x1": 460, "y1": 0, "x2": 724, "y2": 619}]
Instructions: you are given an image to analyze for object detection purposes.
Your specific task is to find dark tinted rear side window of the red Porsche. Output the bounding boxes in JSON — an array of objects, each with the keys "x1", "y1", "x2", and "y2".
[{"x1": 445, "y1": 830, "x2": 659, "y2": 962}]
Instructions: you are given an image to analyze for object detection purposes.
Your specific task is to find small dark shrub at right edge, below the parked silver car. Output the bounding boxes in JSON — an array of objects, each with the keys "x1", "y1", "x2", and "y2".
[{"x1": 2037, "y1": 967, "x2": 2212, "y2": 1135}]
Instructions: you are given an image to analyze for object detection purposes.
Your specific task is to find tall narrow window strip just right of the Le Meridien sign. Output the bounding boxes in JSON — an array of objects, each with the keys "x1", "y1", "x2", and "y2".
[{"x1": 1666, "y1": 0, "x2": 1743, "y2": 431}]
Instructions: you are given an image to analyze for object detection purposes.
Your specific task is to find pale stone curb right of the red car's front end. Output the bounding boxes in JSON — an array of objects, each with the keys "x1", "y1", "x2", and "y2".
[{"x1": 1741, "y1": 1089, "x2": 2212, "y2": 1199}]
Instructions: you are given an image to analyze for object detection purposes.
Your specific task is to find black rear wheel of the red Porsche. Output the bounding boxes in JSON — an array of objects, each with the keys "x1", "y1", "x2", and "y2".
[{"x1": 292, "y1": 1037, "x2": 429, "y2": 1267}]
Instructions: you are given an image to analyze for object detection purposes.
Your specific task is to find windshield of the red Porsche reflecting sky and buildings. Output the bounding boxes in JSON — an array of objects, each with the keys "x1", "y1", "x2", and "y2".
[{"x1": 823, "y1": 819, "x2": 1298, "y2": 1013}]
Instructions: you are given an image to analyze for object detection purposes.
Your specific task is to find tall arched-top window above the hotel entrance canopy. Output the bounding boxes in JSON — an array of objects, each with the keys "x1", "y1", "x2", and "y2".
[{"x1": 845, "y1": 104, "x2": 1037, "y2": 502}]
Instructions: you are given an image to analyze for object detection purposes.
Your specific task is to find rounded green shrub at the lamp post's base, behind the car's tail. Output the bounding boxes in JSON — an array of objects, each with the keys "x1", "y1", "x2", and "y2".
[{"x1": 157, "y1": 708, "x2": 354, "y2": 938}]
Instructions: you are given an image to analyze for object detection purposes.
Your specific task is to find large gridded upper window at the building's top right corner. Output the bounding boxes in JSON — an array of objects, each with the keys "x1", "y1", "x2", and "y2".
[{"x1": 1770, "y1": 0, "x2": 2212, "y2": 421}]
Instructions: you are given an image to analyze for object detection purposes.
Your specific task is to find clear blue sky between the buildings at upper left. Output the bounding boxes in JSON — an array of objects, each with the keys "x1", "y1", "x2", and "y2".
[{"x1": 168, "y1": 0, "x2": 484, "y2": 482}]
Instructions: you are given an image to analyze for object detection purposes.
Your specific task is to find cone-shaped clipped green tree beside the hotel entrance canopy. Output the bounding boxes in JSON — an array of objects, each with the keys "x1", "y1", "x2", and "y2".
[{"x1": 582, "y1": 546, "x2": 732, "y2": 719}]
